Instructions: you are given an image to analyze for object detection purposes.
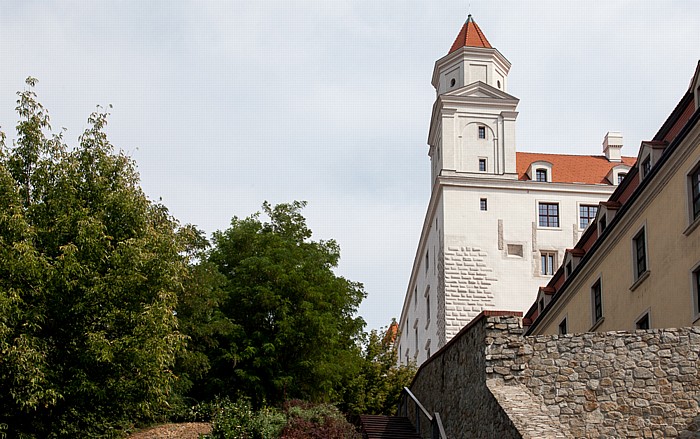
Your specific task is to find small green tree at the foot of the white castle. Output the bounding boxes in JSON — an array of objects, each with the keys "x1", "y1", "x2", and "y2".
[{"x1": 341, "y1": 321, "x2": 416, "y2": 416}]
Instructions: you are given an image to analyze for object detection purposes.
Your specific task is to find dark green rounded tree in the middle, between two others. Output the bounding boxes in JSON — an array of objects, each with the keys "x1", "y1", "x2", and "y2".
[{"x1": 202, "y1": 201, "x2": 365, "y2": 404}]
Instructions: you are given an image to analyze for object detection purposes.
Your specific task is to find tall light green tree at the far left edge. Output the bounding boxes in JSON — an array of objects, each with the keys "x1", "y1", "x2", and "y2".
[{"x1": 0, "y1": 78, "x2": 185, "y2": 437}]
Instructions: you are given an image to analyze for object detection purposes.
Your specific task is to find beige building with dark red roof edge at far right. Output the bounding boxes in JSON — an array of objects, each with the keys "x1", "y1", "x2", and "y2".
[{"x1": 525, "y1": 63, "x2": 700, "y2": 335}]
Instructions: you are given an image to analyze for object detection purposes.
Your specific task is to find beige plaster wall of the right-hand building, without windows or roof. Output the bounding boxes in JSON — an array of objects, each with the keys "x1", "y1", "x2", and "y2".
[{"x1": 533, "y1": 127, "x2": 700, "y2": 334}]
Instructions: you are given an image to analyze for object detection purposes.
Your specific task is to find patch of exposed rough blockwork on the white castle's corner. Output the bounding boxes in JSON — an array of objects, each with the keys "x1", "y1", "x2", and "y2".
[{"x1": 444, "y1": 246, "x2": 497, "y2": 340}]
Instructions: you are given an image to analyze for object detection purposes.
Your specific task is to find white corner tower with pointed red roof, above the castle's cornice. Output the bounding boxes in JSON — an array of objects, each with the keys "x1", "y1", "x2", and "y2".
[{"x1": 428, "y1": 15, "x2": 518, "y2": 183}]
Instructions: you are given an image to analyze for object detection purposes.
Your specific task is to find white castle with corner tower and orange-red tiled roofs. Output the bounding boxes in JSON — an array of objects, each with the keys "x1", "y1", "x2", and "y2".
[{"x1": 398, "y1": 15, "x2": 635, "y2": 364}]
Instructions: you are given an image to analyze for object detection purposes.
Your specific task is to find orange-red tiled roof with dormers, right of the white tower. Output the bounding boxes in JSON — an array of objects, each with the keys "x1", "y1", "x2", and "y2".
[{"x1": 515, "y1": 152, "x2": 637, "y2": 184}]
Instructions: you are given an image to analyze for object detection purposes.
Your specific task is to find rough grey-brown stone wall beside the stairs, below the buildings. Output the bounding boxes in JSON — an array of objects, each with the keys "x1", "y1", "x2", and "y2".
[{"x1": 411, "y1": 311, "x2": 700, "y2": 439}]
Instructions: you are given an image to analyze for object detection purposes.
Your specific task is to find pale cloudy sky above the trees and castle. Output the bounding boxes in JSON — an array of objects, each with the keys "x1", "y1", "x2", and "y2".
[{"x1": 0, "y1": 0, "x2": 700, "y2": 329}]
